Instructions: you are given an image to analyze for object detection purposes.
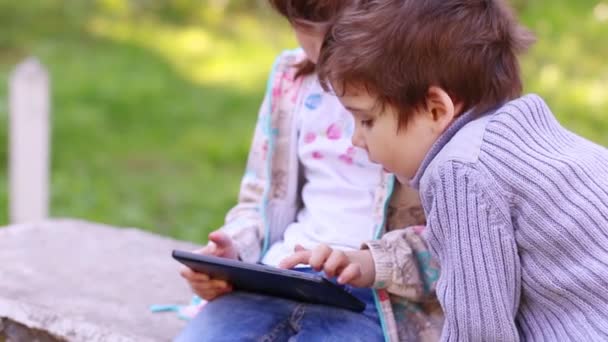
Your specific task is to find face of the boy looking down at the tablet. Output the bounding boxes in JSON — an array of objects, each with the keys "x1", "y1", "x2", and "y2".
[{"x1": 337, "y1": 84, "x2": 453, "y2": 183}]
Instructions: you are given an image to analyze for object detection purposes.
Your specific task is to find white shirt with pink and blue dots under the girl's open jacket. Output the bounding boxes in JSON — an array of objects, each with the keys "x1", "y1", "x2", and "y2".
[{"x1": 263, "y1": 77, "x2": 381, "y2": 266}]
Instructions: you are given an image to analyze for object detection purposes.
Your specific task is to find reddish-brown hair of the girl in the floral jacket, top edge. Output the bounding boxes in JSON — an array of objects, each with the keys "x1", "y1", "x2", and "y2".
[{"x1": 268, "y1": 0, "x2": 356, "y2": 78}]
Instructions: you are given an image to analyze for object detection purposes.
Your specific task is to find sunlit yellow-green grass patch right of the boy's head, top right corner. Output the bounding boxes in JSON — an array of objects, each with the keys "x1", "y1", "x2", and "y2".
[{"x1": 522, "y1": 0, "x2": 608, "y2": 146}]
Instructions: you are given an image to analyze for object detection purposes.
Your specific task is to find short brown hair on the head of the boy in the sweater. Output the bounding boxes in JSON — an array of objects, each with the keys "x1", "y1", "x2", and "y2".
[{"x1": 317, "y1": 0, "x2": 534, "y2": 126}]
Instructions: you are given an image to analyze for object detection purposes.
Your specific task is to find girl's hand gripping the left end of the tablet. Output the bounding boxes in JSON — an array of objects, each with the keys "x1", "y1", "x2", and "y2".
[{"x1": 180, "y1": 231, "x2": 238, "y2": 300}]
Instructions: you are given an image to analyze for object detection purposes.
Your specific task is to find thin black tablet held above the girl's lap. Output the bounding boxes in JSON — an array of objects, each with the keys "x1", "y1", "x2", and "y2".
[{"x1": 173, "y1": 250, "x2": 365, "y2": 312}]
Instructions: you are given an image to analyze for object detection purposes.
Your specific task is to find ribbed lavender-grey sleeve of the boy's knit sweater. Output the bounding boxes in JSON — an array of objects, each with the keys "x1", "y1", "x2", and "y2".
[{"x1": 423, "y1": 162, "x2": 521, "y2": 341}]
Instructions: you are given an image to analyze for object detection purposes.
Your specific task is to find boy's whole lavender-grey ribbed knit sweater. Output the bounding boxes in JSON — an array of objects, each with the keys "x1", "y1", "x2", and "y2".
[{"x1": 412, "y1": 95, "x2": 608, "y2": 342}]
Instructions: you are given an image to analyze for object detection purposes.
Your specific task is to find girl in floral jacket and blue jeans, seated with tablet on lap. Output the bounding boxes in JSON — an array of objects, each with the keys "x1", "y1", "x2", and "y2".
[{"x1": 177, "y1": 0, "x2": 440, "y2": 341}]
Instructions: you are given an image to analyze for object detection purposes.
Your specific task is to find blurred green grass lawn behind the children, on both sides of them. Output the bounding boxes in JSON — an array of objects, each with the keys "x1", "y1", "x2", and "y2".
[{"x1": 0, "y1": 0, "x2": 608, "y2": 242}]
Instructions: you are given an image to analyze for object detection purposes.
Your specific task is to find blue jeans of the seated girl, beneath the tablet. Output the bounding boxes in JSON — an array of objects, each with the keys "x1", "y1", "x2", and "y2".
[{"x1": 175, "y1": 268, "x2": 384, "y2": 342}]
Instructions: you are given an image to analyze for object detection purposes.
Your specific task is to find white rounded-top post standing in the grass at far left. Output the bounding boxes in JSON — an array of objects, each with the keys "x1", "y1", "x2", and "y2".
[{"x1": 9, "y1": 58, "x2": 50, "y2": 223}]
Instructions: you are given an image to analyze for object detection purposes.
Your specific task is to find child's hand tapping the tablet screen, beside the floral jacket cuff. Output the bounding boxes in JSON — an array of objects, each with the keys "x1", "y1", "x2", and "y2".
[{"x1": 279, "y1": 244, "x2": 376, "y2": 287}]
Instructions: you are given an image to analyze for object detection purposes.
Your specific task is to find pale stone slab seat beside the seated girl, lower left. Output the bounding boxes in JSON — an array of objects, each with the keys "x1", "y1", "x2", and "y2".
[{"x1": 0, "y1": 220, "x2": 200, "y2": 341}]
